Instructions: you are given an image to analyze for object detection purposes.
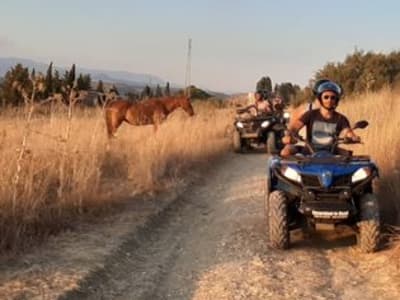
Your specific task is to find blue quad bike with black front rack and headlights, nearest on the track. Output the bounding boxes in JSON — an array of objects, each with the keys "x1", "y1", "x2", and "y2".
[{"x1": 265, "y1": 121, "x2": 380, "y2": 253}]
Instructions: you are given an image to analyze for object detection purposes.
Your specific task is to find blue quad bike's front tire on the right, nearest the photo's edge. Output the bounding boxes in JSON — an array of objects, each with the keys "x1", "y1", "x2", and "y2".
[{"x1": 357, "y1": 194, "x2": 380, "y2": 253}]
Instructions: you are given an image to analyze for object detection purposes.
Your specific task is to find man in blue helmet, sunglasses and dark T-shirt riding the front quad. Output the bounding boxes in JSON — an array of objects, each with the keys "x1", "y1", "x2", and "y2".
[{"x1": 281, "y1": 79, "x2": 360, "y2": 157}]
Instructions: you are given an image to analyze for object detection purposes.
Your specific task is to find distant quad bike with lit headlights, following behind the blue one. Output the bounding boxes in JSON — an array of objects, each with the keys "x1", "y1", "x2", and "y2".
[{"x1": 232, "y1": 107, "x2": 290, "y2": 154}]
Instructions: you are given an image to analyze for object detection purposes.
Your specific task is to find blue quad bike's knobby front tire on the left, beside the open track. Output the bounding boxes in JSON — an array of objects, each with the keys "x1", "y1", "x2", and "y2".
[{"x1": 265, "y1": 191, "x2": 290, "y2": 250}]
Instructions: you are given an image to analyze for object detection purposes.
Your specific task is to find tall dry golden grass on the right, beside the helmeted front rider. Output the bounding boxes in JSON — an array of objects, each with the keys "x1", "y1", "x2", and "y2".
[{"x1": 339, "y1": 89, "x2": 400, "y2": 223}]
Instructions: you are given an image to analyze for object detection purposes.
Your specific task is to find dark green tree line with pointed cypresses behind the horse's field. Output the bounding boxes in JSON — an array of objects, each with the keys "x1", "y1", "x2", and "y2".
[{"x1": 0, "y1": 63, "x2": 211, "y2": 107}]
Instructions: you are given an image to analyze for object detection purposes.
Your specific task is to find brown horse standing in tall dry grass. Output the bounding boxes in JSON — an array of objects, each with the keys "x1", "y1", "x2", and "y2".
[{"x1": 105, "y1": 96, "x2": 194, "y2": 137}]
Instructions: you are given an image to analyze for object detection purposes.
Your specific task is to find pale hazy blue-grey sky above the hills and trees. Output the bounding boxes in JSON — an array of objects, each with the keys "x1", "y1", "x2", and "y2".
[{"x1": 0, "y1": 0, "x2": 400, "y2": 92}]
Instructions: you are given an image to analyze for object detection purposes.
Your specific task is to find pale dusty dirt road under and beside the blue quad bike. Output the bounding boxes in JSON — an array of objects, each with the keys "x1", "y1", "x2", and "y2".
[{"x1": 59, "y1": 154, "x2": 400, "y2": 299}]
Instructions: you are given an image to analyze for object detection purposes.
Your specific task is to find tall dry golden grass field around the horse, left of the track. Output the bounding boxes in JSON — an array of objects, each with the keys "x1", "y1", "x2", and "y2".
[{"x1": 0, "y1": 104, "x2": 232, "y2": 250}]
